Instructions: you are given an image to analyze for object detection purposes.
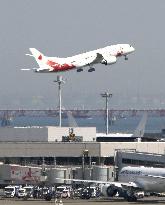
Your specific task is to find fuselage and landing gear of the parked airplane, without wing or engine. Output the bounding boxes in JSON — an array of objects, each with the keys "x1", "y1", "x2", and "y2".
[{"x1": 118, "y1": 166, "x2": 165, "y2": 201}]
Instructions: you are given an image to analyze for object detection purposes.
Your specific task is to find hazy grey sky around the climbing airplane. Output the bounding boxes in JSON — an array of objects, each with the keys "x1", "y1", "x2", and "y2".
[{"x1": 0, "y1": 0, "x2": 165, "y2": 109}]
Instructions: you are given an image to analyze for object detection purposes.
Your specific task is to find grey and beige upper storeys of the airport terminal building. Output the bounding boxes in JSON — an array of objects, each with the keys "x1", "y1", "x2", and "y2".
[{"x1": 0, "y1": 127, "x2": 165, "y2": 167}]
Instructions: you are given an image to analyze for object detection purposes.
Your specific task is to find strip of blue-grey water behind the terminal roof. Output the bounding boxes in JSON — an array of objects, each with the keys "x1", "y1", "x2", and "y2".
[{"x1": 7, "y1": 116, "x2": 165, "y2": 133}]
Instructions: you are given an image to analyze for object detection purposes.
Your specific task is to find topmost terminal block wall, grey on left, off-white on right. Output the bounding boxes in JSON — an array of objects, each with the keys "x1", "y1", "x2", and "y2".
[{"x1": 0, "y1": 126, "x2": 96, "y2": 142}]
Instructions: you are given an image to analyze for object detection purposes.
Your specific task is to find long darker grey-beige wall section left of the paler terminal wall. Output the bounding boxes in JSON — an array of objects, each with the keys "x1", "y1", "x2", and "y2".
[{"x1": 0, "y1": 142, "x2": 100, "y2": 157}]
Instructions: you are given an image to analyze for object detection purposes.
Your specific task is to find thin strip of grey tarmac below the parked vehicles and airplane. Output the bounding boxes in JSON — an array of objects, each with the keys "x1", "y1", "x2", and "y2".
[{"x1": 0, "y1": 197, "x2": 165, "y2": 205}]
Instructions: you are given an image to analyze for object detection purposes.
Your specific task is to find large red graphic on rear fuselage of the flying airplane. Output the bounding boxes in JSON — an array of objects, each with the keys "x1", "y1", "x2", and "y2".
[{"x1": 46, "y1": 60, "x2": 76, "y2": 72}]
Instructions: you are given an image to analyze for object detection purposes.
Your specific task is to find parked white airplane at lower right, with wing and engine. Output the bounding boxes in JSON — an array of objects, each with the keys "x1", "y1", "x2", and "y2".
[{"x1": 57, "y1": 166, "x2": 165, "y2": 202}]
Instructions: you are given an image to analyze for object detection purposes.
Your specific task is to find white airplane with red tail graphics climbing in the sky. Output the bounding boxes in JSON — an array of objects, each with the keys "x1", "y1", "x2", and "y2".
[{"x1": 21, "y1": 44, "x2": 135, "y2": 73}]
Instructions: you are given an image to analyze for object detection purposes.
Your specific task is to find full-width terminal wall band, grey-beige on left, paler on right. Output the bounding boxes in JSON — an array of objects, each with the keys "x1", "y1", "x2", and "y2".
[{"x1": 0, "y1": 142, "x2": 165, "y2": 157}]
